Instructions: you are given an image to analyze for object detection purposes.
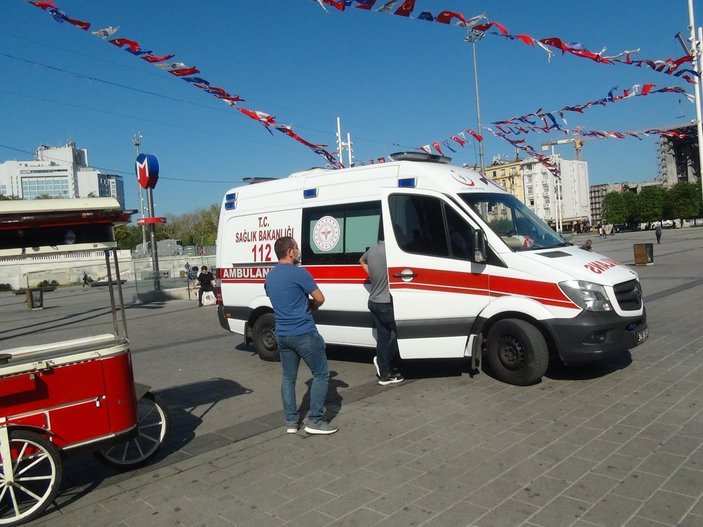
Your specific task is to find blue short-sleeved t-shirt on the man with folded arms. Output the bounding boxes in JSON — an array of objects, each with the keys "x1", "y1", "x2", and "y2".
[{"x1": 264, "y1": 263, "x2": 317, "y2": 337}]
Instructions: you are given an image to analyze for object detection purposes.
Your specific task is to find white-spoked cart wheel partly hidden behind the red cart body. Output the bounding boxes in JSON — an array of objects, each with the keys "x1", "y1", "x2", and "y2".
[{"x1": 95, "y1": 392, "x2": 170, "y2": 468}]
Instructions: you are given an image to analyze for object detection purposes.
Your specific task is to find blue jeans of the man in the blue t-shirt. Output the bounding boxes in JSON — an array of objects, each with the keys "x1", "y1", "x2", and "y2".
[{"x1": 276, "y1": 331, "x2": 330, "y2": 424}]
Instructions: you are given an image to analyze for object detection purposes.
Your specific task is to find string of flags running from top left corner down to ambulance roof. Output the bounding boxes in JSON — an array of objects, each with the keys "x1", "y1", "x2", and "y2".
[{"x1": 28, "y1": 0, "x2": 344, "y2": 168}]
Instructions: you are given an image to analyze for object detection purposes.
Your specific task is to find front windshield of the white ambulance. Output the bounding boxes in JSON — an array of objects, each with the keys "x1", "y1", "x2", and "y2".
[{"x1": 460, "y1": 193, "x2": 571, "y2": 251}]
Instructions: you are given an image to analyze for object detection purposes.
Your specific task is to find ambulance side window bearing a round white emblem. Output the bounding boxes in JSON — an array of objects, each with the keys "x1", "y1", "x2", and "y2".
[{"x1": 300, "y1": 201, "x2": 382, "y2": 265}]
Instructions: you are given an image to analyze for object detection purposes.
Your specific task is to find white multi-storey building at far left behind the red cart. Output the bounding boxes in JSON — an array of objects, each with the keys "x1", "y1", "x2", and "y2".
[{"x1": 0, "y1": 141, "x2": 125, "y2": 209}]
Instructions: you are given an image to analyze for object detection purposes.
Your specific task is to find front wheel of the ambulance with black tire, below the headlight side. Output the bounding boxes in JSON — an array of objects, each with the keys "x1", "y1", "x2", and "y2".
[{"x1": 486, "y1": 318, "x2": 549, "y2": 386}]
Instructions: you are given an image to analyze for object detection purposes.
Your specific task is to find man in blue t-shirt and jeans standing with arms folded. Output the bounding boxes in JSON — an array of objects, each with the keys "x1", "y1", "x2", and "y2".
[{"x1": 264, "y1": 236, "x2": 338, "y2": 435}]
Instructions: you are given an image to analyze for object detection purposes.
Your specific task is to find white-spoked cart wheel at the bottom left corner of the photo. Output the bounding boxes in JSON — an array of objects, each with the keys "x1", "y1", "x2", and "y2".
[{"x1": 0, "y1": 430, "x2": 61, "y2": 525}]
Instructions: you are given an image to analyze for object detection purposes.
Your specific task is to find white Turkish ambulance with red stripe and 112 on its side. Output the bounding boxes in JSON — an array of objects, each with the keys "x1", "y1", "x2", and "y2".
[{"x1": 217, "y1": 153, "x2": 648, "y2": 385}]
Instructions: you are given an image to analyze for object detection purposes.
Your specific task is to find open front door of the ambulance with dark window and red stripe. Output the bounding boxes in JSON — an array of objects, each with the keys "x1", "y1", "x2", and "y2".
[{"x1": 382, "y1": 189, "x2": 489, "y2": 358}]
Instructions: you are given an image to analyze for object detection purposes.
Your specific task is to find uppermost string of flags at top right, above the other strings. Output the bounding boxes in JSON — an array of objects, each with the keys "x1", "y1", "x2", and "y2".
[{"x1": 314, "y1": 0, "x2": 700, "y2": 84}]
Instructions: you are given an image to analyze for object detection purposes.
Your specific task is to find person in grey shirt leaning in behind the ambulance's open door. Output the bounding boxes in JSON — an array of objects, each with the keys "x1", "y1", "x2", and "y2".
[{"x1": 359, "y1": 240, "x2": 405, "y2": 386}]
